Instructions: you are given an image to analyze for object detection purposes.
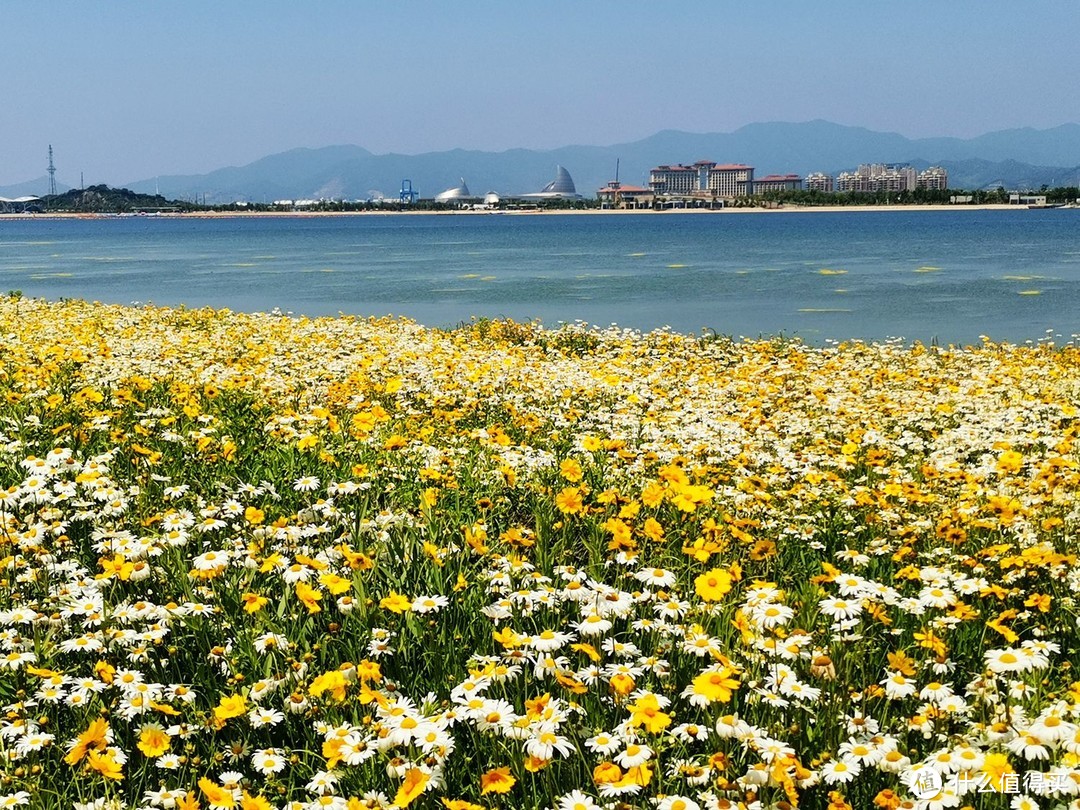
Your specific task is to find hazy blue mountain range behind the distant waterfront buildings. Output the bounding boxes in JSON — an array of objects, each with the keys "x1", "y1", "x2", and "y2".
[{"x1": 8, "y1": 121, "x2": 1080, "y2": 203}]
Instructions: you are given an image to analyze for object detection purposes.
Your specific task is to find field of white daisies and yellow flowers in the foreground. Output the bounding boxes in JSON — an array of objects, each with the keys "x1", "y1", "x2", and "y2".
[{"x1": 0, "y1": 296, "x2": 1080, "y2": 810}]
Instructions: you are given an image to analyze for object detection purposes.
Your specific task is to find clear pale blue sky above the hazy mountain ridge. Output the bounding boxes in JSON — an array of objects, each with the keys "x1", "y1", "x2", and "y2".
[{"x1": 0, "y1": 0, "x2": 1080, "y2": 185}]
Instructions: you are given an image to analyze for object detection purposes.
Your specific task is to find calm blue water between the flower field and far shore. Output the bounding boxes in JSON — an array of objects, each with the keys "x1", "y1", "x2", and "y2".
[{"x1": 0, "y1": 210, "x2": 1080, "y2": 343}]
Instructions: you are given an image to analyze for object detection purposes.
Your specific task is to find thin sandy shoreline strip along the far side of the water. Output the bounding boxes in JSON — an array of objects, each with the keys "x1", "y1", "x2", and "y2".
[{"x1": 0, "y1": 204, "x2": 1045, "y2": 221}]
